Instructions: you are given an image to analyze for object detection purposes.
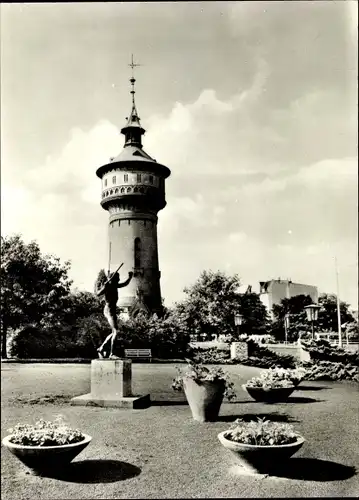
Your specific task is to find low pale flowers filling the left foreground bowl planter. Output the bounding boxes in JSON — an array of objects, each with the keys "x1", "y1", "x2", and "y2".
[{"x1": 8, "y1": 416, "x2": 85, "y2": 446}]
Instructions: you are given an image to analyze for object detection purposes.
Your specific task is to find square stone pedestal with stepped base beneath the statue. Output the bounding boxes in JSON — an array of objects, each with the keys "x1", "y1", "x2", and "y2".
[{"x1": 71, "y1": 359, "x2": 151, "y2": 409}]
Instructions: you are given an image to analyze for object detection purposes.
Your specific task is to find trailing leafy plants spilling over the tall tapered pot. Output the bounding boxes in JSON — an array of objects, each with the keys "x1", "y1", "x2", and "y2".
[{"x1": 172, "y1": 359, "x2": 236, "y2": 400}]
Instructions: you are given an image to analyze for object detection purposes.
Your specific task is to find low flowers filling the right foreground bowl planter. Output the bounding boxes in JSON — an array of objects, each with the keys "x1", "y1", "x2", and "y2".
[{"x1": 225, "y1": 418, "x2": 301, "y2": 446}]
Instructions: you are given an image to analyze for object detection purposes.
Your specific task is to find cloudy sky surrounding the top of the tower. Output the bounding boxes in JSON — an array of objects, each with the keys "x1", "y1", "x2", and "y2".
[{"x1": 1, "y1": 0, "x2": 358, "y2": 309}]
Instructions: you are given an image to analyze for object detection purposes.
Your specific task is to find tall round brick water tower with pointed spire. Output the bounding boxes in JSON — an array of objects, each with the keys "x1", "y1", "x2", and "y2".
[{"x1": 96, "y1": 67, "x2": 171, "y2": 317}]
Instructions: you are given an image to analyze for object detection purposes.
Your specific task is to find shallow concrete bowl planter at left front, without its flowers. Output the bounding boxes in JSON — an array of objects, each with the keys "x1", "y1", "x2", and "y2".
[{"x1": 2, "y1": 434, "x2": 92, "y2": 475}]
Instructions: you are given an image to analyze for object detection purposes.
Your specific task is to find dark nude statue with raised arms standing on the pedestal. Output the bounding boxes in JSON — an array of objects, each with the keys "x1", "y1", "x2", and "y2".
[{"x1": 96, "y1": 266, "x2": 133, "y2": 358}]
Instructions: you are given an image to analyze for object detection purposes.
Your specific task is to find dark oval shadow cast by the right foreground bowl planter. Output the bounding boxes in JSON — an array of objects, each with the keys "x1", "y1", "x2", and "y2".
[{"x1": 269, "y1": 458, "x2": 356, "y2": 482}]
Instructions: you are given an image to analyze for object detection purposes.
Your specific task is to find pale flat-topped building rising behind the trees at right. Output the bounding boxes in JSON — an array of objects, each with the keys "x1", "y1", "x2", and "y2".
[{"x1": 259, "y1": 278, "x2": 318, "y2": 319}]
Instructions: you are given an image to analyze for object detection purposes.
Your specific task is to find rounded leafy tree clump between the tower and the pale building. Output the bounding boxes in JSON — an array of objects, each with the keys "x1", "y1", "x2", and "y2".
[{"x1": 175, "y1": 271, "x2": 268, "y2": 339}]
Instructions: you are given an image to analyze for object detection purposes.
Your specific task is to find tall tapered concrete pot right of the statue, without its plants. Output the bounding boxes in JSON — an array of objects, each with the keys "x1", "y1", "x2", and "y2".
[{"x1": 183, "y1": 377, "x2": 225, "y2": 422}]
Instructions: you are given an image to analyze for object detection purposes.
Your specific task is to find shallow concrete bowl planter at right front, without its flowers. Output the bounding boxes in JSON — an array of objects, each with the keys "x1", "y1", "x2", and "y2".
[{"x1": 218, "y1": 431, "x2": 305, "y2": 474}]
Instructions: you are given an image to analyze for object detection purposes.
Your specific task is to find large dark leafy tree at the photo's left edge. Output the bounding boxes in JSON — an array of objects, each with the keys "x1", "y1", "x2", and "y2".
[{"x1": 0, "y1": 235, "x2": 72, "y2": 358}]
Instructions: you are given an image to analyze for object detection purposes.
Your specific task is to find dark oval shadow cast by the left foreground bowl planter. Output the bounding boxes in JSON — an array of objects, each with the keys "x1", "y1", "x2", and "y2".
[{"x1": 47, "y1": 460, "x2": 141, "y2": 483}]
